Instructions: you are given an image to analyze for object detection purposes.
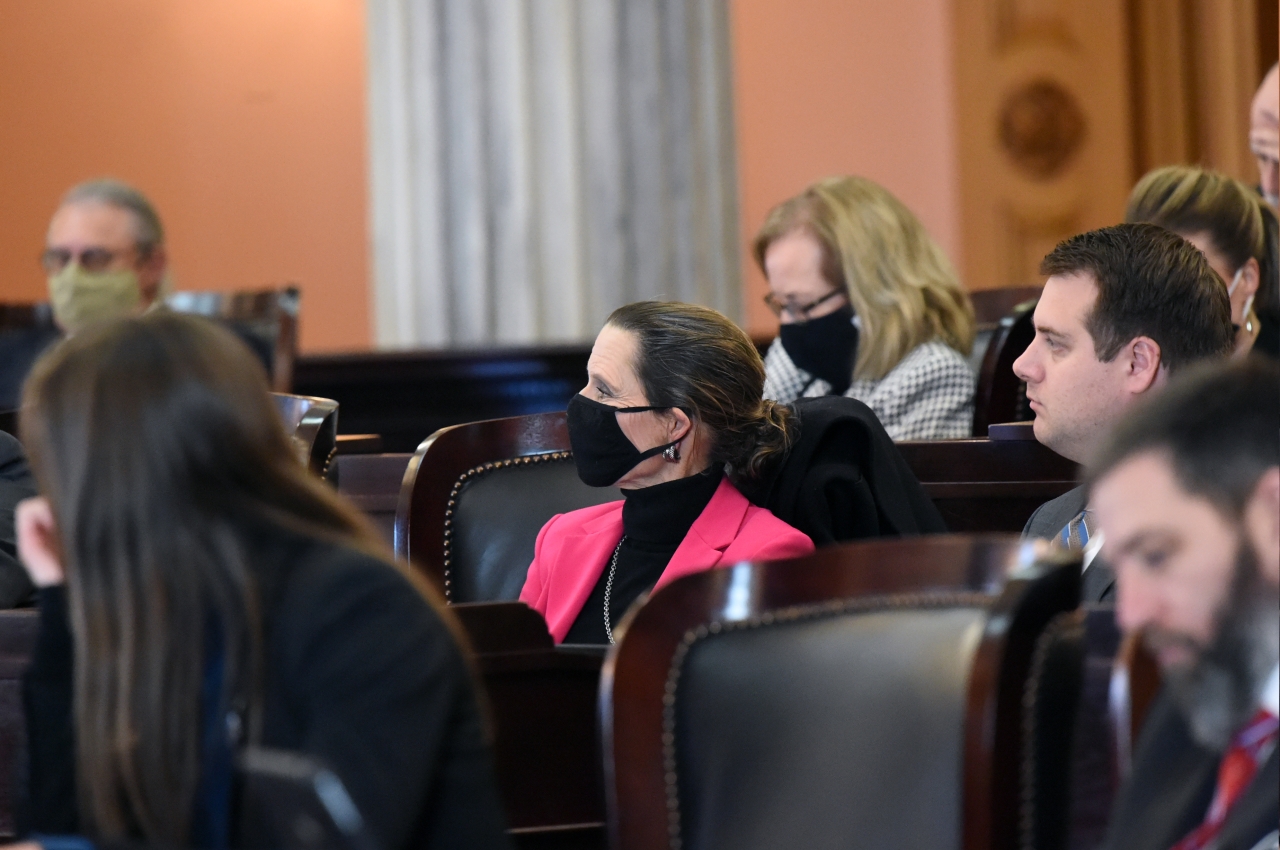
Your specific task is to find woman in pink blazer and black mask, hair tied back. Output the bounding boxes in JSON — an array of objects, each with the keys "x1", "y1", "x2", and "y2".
[{"x1": 520, "y1": 301, "x2": 813, "y2": 644}]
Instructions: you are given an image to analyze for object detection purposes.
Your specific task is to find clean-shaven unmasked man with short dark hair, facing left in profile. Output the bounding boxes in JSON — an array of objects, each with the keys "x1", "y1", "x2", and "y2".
[{"x1": 1014, "y1": 224, "x2": 1234, "y2": 602}]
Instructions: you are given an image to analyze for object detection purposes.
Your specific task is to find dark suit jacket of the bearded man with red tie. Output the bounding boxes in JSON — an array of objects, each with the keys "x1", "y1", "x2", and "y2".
[{"x1": 1103, "y1": 693, "x2": 1280, "y2": 850}]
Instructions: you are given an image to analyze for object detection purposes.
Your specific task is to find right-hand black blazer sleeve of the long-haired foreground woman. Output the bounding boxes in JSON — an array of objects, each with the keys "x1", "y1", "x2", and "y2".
[{"x1": 268, "y1": 549, "x2": 506, "y2": 850}]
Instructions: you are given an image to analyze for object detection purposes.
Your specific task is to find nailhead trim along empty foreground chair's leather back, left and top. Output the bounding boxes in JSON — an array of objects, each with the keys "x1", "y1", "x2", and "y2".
[{"x1": 662, "y1": 593, "x2": 991, "y2": 850}]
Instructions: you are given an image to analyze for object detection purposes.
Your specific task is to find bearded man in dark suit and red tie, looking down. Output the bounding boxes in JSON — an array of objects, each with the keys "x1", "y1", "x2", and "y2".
[{"x1": 1089, "y1": 358, "x2": 1280, "y2": 850}]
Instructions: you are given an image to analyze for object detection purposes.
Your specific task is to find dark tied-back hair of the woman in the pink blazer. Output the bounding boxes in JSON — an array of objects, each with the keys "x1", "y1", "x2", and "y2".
[{"x1": 608, "y1": 301, "x2": 794, "y2": 481}]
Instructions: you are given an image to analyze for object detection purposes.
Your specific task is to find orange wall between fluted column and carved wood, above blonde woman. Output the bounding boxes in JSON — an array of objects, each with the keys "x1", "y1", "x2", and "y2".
[{"x1": 730, "y1": 0, "x2": 961, "y2": 333}]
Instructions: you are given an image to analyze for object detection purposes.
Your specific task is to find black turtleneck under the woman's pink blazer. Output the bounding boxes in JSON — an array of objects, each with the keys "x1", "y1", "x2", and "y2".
[{"x1": 564, "y1": 467, "x2": 724, "y2": 644}]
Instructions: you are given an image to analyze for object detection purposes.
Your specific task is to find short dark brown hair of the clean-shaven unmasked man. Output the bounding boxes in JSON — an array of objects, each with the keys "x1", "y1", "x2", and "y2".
[{"x1": 1041, "y1": 224, "x2": 1235, "y2": 373}]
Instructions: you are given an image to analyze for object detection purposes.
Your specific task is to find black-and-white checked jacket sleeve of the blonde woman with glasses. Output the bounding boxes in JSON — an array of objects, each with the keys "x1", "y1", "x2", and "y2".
[{"x1": 849, "y1": 341, "x2": 977, "y2": 440}]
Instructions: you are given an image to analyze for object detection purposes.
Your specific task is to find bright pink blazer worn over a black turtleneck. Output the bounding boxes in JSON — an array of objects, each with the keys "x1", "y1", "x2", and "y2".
[{"x1": 520, "y1": 479, "x2": 813, "y2": 644}]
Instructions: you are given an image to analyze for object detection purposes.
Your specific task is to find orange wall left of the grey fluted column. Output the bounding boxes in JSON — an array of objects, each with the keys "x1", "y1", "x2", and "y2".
[{"x1": 0, "y1": 0, "x2": 370, "y2": 349}]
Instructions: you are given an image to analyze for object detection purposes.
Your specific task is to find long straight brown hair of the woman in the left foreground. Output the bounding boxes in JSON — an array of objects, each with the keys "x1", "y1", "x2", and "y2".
[{"x1": 22, "y1": 311, "x2": 424, "y2": 846}]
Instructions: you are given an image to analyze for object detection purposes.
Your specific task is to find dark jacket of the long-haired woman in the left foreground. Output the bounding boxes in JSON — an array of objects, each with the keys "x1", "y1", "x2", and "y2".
[{"x1": 19, "y1": 531, "x2": 507, "y2": 850}]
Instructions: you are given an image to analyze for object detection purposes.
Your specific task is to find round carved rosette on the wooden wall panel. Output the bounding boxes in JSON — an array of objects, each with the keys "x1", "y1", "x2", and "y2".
[{"x1": 1000, "y1": 78, "x2": 1085, "y2": 180}]
